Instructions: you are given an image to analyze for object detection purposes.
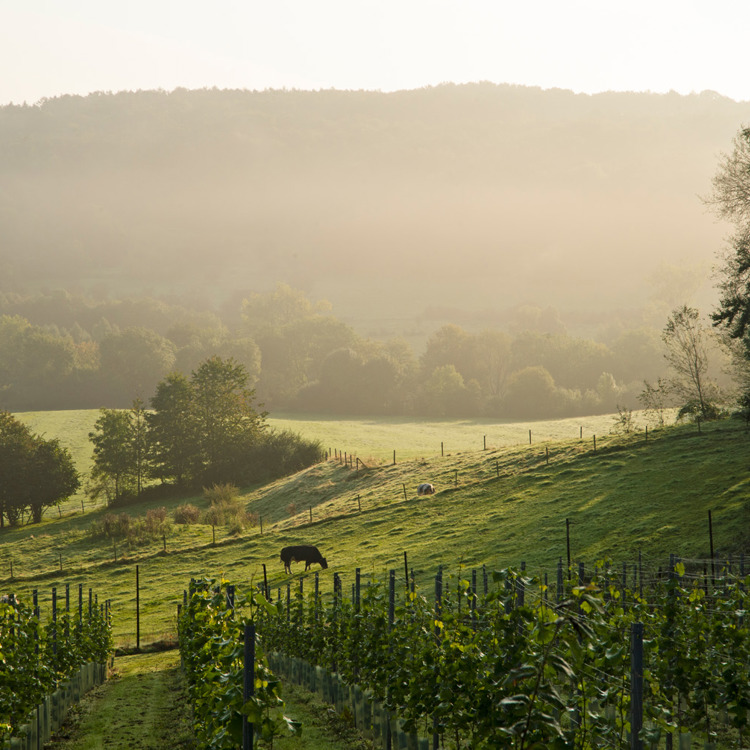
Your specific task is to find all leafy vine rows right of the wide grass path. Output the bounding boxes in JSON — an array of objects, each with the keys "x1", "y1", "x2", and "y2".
[{"x1": 180, "y1": 560, "x2": 750, "y2": 750}]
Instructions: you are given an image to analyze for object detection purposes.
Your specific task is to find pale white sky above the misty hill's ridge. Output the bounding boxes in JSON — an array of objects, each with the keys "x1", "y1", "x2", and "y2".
[{"x1": 0, "y1": 0, "x2": 750, "y2": 104}]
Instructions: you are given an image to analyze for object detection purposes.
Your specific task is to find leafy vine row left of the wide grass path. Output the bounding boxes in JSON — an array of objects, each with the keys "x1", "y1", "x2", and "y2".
[{"x1": 0, "y1": 586, "x2": 112, "y2": 749}]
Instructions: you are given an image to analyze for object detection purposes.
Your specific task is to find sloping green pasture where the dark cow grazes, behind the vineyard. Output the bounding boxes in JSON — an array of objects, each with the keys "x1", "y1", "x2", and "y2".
[{"x1": 0, "y1": 412, "x2": 750, "y2": 646}]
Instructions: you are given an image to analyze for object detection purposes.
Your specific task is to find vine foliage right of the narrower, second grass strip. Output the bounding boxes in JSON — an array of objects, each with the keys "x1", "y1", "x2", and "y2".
[{"x1": 260, "y1": 562, "x2": 750, "y2": 750}]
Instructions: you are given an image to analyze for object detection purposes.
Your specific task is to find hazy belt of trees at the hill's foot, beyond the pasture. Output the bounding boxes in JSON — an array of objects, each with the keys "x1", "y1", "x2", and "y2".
[{"x1": 0, "y1": 285, "x2": 688, "y2": 419}]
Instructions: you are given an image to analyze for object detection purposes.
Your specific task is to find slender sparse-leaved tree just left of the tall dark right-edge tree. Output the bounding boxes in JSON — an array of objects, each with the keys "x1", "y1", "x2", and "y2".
[{"x1": 662, "y1": 305, "x2": 719, "y2": 419}]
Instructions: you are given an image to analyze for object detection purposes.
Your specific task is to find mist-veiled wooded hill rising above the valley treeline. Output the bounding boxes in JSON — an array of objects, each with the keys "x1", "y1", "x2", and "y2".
[{"x1": 0, "y1": 83, "x2": 750, "y2": 335}]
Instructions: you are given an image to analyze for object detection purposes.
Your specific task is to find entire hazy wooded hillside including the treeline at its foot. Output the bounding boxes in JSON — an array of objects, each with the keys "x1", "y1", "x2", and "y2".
[{"x1": 0, "y1": 83, "x2": 750, "y2": 418}]
